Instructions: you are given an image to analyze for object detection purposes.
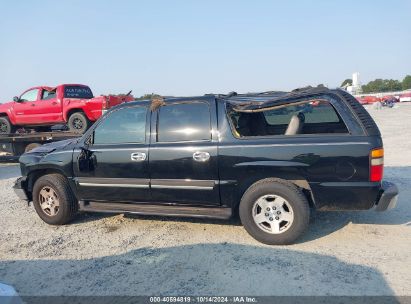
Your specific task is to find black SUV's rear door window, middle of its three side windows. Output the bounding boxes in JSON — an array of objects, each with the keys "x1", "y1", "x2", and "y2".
[{"x1": 157, "y1": 102, "x2": 211, "y2": 142}]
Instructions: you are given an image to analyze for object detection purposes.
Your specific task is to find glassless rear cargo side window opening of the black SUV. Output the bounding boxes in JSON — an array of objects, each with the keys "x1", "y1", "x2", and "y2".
[{"x1": 229, "y1": 99, "x2": 348, "y2": 137}]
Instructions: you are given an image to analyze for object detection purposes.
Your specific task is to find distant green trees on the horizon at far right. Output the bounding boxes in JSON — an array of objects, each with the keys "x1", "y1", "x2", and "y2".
[{"x1": 341, "y1": 75, "x2": 411, "y2": 93}]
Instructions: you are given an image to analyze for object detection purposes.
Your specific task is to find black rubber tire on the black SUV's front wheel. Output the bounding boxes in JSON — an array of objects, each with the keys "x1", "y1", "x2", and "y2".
[{"x1": 33, "y1": 174, "x2": 78, "y2": 225}]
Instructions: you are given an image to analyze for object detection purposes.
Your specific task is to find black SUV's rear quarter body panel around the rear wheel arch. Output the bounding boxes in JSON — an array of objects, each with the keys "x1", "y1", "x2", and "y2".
[{"x1": 218, "y1": 104, "x2": 382, "y2": 210}]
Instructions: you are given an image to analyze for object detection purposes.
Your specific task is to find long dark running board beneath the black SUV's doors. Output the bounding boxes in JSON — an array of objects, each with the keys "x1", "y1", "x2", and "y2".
[{"x1": 79, "y1": 201, "x2": 232, "y2": 219}]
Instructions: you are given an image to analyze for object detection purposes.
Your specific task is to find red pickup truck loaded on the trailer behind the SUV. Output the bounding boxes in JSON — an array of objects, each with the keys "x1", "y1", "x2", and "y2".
[{"x1": 0, "y1": 84, "x2": 134, "y2": 134}]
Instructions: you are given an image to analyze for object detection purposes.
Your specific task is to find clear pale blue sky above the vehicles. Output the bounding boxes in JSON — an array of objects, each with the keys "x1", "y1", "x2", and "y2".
[{"x1": 0, "y1": 0, "x2": 411, "y2": 102}]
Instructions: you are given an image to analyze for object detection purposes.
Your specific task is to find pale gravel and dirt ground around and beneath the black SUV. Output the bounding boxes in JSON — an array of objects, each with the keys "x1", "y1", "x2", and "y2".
[{"x1": 0, "y1": 104, "x2": 411, "y2": 296}]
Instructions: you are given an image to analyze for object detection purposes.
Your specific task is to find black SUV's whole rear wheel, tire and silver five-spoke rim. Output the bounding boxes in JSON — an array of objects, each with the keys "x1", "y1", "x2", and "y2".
[{"x1": 239, "y1": 178, "x2": 310, "y2": 245}]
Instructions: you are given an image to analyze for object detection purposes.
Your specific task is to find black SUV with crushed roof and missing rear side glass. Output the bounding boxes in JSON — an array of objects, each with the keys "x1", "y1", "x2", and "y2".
[{"x1": 14, "y1": 87, "x2": 398, "y2": 244}]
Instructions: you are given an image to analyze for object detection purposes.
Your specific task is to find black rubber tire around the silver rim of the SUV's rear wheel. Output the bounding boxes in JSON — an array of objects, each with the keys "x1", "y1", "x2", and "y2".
[{"x1": 239, "y1": 178, "x2": 310, "y2": 245}]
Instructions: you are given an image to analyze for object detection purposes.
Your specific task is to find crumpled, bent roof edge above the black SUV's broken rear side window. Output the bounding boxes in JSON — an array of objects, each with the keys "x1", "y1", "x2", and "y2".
[{"x1": 222, "y1": 86, "x2": 331, "y2": 112}]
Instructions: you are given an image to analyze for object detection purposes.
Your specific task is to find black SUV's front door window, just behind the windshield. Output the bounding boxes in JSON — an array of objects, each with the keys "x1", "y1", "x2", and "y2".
[{"x1": 93, "y1": 107, "x2": 147, "y2": 145}]
